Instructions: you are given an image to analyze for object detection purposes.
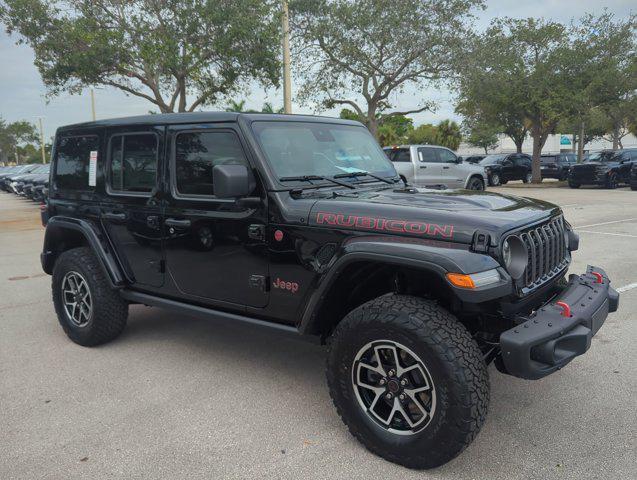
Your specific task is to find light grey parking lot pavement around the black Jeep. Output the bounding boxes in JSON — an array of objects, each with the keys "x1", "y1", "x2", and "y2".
[{"x1": 0, "y1": 185, "x2": 637, "y2": 480}]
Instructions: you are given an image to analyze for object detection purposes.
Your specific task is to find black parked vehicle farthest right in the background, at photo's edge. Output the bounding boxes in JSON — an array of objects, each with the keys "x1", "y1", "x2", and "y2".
[{"x1": 568, "y1": 148, "x2": 637, "y2": 188}]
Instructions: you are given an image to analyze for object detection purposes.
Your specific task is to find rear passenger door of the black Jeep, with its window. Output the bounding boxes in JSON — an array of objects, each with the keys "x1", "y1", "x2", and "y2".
[{"x1": 98, "y1": 126, "x2": 164, "y2": 287}]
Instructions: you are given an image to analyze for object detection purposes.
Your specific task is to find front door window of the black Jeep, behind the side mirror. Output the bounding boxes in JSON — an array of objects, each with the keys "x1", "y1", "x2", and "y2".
[{"x1": 175, "y1": 131, "x2": 248, "y2": 196}]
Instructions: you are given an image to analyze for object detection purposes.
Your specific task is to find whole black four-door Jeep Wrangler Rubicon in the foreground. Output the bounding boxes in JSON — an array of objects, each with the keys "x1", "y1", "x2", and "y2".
[{"x1": 42, "y1": 113, "x2": 619, "y2": 468}]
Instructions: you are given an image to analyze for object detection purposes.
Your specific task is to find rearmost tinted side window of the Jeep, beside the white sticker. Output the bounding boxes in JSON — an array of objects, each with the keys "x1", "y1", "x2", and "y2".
[{"x1": 54, "y1": 135, "x2": 99, "y2": 190}]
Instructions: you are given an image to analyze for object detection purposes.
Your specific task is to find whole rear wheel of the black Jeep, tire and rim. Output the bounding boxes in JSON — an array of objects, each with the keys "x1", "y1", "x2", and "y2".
[{"x1": 51, "y1": 247, "x2": 128, "y2": 347}]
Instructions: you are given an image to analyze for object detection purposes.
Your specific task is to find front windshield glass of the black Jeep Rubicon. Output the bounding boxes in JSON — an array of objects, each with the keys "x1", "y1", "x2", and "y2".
[{"x1": 252, "y1": 122, "x2": 396, "y2": 184}]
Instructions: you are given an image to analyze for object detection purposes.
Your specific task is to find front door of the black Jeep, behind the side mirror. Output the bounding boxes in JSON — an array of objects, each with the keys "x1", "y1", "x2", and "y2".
[{"x1": 164, "y1": 124, "x2": 269, "y2": 307}]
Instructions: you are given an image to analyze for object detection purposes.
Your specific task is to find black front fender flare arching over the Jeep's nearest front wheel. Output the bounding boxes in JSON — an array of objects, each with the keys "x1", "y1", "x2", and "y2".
[{"x1": 298, "y1": 236, "x2": 512, "y2": 334}]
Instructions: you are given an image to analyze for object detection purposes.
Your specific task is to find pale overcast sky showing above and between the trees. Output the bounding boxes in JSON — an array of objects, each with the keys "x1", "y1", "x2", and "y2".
[{"x1": 0, "y1": 0, "x2": 637, "y2": 138}]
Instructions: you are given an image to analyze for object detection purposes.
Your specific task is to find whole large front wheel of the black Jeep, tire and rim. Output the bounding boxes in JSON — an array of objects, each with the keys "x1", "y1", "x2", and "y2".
[{"x1": 327, "y1": 295, "x2": 489, "y2": 469}]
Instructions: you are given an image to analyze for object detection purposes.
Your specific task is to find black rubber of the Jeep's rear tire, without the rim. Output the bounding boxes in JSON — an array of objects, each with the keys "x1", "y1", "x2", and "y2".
[{"x1": 51, "y1": 247, "x2": 128, "y2": 347}]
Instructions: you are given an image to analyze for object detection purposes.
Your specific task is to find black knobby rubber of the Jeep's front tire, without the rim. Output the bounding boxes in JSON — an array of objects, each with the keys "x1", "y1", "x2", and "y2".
[{"x1": 326, "y1": 294, "x2": 489, "y2": 469}]
